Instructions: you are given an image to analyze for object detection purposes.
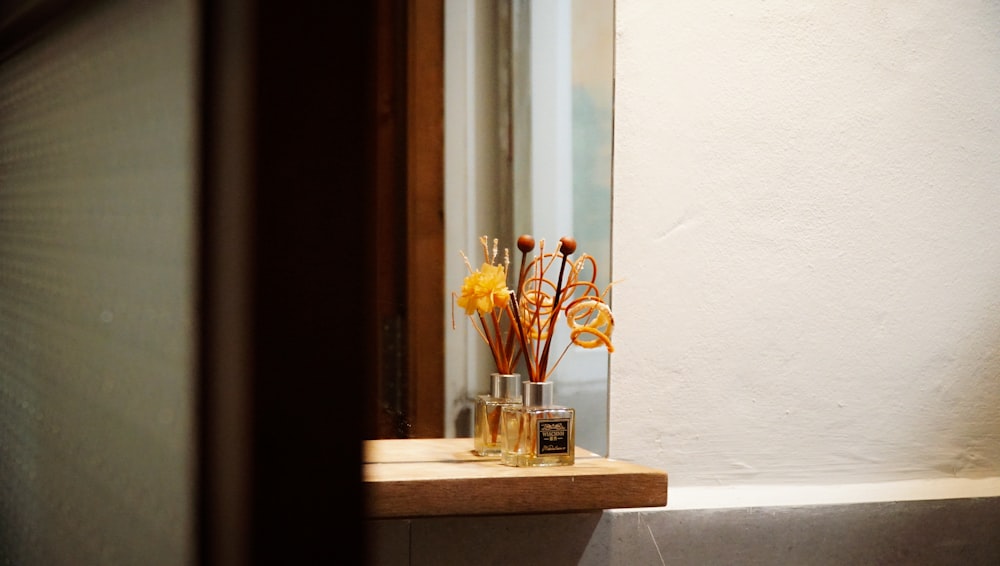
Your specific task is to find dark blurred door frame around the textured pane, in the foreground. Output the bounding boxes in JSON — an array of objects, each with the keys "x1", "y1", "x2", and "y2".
[{"x1": 0, "y1": 0, "x2": 376, "y2": 565}]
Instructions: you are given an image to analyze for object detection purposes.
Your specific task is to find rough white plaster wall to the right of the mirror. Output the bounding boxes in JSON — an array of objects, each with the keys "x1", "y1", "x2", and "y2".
[{"x1": 609, "y1": 0, "x2": 1000, "y2": 489}]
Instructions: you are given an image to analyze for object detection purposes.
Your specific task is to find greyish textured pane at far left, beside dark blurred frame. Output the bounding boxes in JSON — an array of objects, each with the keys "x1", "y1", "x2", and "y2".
[{"x1": 0, "y1": 0, "x2": 197, "y2": 565}]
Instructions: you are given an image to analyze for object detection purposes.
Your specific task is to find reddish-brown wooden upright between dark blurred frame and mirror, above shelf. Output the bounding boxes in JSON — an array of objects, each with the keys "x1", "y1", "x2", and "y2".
[{"x1": 368, "y1": 0, "x2": 445, "y2": 438}]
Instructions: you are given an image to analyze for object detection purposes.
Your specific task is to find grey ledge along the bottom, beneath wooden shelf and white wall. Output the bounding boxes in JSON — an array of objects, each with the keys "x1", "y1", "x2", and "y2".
[{"x1": 369, "y1": 498, "x2": 1000, "y2": 566}]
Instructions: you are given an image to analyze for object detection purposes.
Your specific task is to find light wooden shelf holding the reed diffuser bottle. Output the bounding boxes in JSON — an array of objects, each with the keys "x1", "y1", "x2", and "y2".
[{"x1": 363, "y1": 438, "x2": 667, "y2": 518}]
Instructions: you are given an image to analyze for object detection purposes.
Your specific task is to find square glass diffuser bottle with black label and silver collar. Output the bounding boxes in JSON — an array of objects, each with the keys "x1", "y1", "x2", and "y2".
[{"x1": 500, "y1": 381, "x2": 576, "y2": 467}]
